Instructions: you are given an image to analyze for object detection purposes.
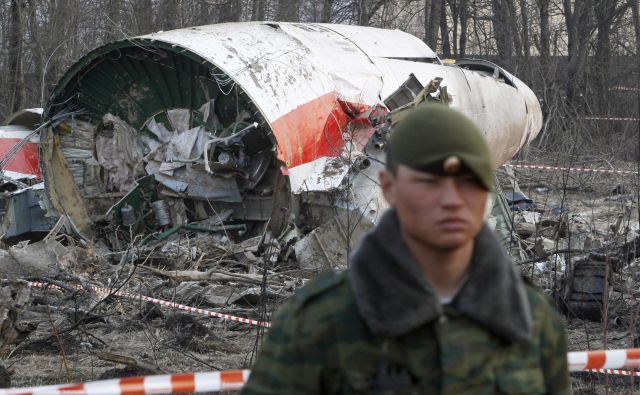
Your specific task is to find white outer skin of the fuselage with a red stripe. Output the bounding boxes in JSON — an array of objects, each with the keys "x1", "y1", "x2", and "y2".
[{"x1": 142, "y1": 23, "x2": 542, "y2": 169}]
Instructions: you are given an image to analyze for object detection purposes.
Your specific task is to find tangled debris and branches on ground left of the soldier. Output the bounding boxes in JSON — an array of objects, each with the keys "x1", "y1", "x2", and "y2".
[{"x1": 0, "y1": 230, "x2": 304, "y2": 387}]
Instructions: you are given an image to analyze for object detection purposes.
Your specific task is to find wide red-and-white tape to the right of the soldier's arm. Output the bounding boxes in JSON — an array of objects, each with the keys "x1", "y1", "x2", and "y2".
[{"x1": 567, "y1": 348, "x2": 640, "y2": 372}]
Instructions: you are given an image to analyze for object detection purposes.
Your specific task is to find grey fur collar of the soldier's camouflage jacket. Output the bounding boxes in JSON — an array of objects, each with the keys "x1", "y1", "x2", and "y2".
[{"x1": 349, "y1": 210, "x2": 533, "y2": 342}]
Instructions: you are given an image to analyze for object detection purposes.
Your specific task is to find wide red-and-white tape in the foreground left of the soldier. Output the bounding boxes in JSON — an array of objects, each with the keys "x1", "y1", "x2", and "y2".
[{"x1": 0, "y1": 370, "x2": 249, "y2": 395}]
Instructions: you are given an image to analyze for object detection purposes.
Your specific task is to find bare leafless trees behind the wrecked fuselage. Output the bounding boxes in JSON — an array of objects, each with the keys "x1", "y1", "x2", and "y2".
[{"x1": 0, "y1": 0, "x2": 640, "y2": 159}]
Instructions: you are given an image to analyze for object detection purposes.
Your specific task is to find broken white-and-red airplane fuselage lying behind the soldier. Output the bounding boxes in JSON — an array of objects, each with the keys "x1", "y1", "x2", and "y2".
[{"x1": 41, "y1": 22, "x2": 542, "y2": 244}]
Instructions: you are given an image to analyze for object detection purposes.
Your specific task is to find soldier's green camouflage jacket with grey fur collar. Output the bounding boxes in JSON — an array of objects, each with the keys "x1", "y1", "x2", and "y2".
[{"x1": 242, "y1": 214, "x2": 571, "y2": 395}]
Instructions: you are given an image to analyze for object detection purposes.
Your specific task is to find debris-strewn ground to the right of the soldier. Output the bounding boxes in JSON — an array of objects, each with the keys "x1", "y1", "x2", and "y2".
[{"x1": 512, "y1": 156, "x2": 640, "y2": 394}]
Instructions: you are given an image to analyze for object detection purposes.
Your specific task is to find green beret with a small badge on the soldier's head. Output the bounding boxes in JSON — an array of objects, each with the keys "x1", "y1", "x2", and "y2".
[{"x1": 388, "y1": 103, "x2": 493, "y2": 191}]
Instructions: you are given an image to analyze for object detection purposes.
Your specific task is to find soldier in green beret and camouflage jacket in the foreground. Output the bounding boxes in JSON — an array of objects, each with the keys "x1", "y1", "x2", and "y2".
[{"x1": 243, "y1": 104, "x2": 571, "y2": 395}]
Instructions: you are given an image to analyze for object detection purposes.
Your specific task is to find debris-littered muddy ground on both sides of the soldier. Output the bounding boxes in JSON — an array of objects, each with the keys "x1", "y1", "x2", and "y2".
[{"x1": 0, "y1": 156, "x2": 640, "y2": 394}]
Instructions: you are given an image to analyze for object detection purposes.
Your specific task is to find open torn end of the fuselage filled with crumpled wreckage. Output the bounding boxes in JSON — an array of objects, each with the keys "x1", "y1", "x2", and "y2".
[{"x1": 41, "y1": 41, "x2": 279, "y2": 244}]
